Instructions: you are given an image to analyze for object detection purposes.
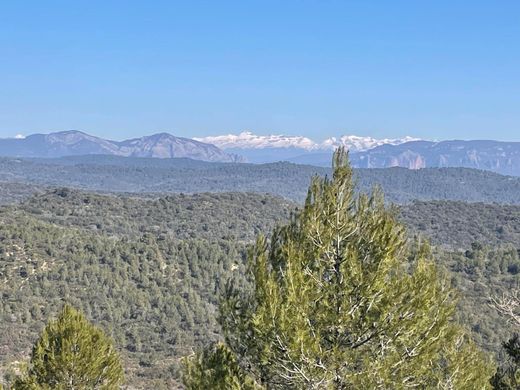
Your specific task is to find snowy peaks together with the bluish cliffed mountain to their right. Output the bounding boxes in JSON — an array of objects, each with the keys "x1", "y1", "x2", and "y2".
[{"x1": 197, "y1": 132, "x2": 520, "y2": 176}]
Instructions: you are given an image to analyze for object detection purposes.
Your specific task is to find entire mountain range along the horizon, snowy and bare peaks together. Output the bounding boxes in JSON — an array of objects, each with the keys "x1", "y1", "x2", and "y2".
[{"x1": 0, "y1": 130, "x2": 520, "y2": 176}]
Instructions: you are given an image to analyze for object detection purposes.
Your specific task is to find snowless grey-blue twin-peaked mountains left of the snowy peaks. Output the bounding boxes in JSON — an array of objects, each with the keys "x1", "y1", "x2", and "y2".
[{"x1": 0, "y1": 130, "x2": 241, "y2": 162}]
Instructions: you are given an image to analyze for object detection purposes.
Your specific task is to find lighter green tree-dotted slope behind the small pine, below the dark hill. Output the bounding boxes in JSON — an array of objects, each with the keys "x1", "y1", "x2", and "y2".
[{"x1": 0, "y1": 210, "x2": 243, "y2": 388}]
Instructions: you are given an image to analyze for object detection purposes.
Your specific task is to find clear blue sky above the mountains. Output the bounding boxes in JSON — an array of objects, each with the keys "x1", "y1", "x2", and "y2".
[{"x1": 0, "y1": 0, "x2": 520, "y2": 141}]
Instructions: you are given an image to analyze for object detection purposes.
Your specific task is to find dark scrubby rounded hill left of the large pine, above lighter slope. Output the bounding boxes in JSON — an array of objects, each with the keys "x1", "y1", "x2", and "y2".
[{"x1": 12, "y1": 188, "x2": 296, "y2": 241}]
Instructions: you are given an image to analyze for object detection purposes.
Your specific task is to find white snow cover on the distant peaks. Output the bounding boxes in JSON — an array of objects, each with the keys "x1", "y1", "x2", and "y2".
[{"x1": 194, "y1": 131, "x2": 419, "y2": 152}]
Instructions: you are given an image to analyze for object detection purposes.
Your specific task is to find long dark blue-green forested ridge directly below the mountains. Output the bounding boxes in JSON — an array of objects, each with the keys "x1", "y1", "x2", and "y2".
[{"x1": 0, "y1": 156, "x2": 520, "y2": 204}]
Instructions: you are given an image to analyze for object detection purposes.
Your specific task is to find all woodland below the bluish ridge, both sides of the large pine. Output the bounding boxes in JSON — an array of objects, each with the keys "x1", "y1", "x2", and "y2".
[{"x1": 0, "y1": 188, "x2": 520, "y2": 388}]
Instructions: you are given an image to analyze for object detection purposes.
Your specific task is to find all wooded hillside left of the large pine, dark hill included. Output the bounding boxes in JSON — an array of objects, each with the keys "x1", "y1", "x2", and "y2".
[{"x1": 0, "y1": 189, "x2": 289, "y2": 389}]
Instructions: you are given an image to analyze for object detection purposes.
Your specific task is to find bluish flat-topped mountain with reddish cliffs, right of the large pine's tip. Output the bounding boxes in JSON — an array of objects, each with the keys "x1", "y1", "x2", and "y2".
[{"x1": 351, "y1": 141, "x2": 520, "y2": 176}]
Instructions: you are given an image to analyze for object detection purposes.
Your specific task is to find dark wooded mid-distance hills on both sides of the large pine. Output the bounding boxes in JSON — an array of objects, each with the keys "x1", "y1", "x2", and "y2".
[{"x1": 16, "y1": 188, "x2": 520, "y2": 250}]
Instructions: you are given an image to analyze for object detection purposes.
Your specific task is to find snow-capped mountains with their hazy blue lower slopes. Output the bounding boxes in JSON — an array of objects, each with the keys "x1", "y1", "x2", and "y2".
[{"x1": 194, "y1": 131, "x2": 418, "y2": 165}]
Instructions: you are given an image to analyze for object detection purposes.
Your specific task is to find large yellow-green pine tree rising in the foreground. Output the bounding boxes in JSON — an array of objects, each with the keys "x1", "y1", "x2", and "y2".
[{"x1": 185, "y1": 149, "x2": 492, "y2": 389}]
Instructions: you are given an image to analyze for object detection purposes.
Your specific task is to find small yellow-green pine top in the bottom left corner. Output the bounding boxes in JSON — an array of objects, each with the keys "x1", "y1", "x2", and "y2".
[{"x1": 13, "y1": 305, "x2": 124, "y2": 390}]
